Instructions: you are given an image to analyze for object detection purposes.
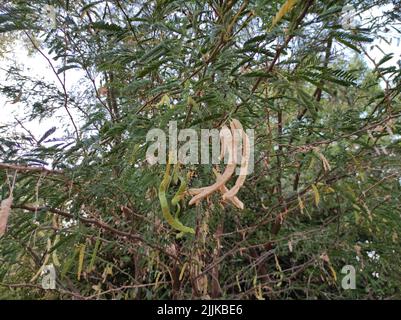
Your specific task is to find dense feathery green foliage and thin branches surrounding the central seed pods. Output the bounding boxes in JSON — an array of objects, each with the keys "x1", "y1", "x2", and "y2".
[{"x1": 0, "y1": 0, "x2": 401, "y2": 299}]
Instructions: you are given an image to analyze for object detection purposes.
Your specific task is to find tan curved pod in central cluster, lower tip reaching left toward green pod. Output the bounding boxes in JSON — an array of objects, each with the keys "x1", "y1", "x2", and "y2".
[{"x1": 189, "y1": 123, "x2": 237, "y2": 205}]
